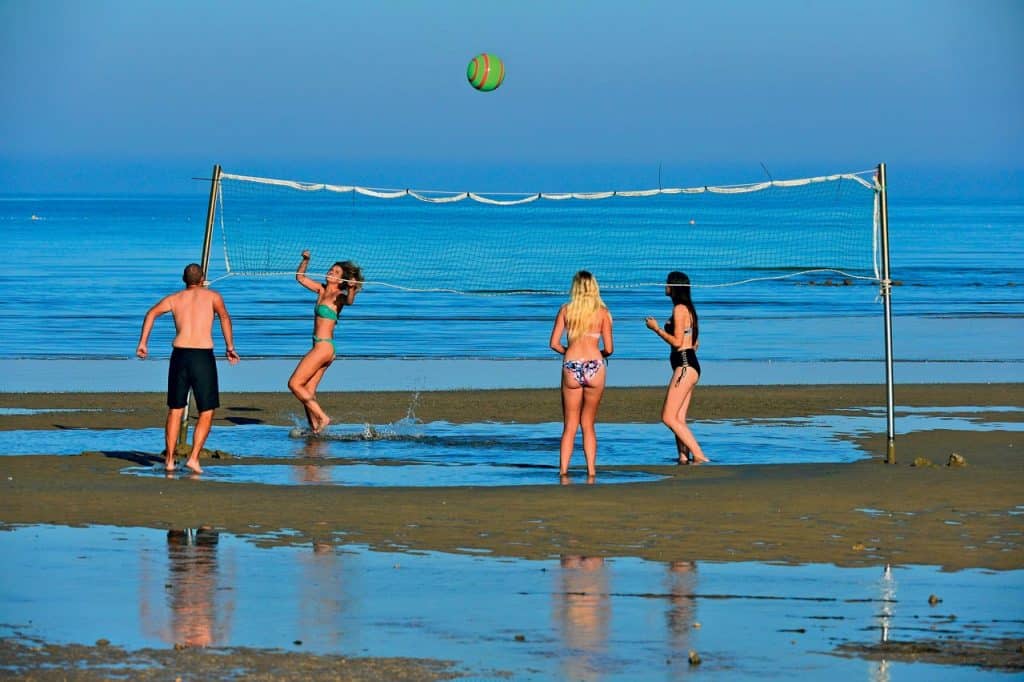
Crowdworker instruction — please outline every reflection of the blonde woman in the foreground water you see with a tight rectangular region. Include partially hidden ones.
[553,554,611,680]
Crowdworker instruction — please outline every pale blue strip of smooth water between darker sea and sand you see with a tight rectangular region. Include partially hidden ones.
[0,355,1024,394]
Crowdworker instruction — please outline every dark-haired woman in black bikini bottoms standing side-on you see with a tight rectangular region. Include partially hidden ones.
[647,270,709,464]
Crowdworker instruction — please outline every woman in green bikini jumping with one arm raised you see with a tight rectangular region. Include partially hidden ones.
[288,250,362,433]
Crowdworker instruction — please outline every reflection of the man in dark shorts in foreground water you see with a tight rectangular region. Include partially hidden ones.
[167,527,227,646]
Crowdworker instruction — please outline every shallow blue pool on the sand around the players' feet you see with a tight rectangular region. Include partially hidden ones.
[0,406,1024,486]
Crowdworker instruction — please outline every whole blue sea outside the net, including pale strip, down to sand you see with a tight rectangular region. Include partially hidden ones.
[0,189,1024,391]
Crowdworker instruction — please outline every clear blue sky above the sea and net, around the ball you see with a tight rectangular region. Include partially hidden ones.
[0,0,1024,193]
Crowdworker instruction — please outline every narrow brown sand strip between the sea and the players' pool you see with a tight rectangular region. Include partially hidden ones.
[0,383,1024,428]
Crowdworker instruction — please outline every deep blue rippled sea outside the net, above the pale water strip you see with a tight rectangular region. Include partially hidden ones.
[0,197,1024,363]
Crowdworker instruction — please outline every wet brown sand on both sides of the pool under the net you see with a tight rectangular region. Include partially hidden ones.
[0,384,1024,570]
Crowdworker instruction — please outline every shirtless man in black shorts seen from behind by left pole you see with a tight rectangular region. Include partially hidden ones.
[135,263,239,474]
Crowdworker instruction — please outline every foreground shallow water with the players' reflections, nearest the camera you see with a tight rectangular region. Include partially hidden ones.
[0,526,1024,681]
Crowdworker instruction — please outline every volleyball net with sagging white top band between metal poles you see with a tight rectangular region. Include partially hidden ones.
[214,169,880,294]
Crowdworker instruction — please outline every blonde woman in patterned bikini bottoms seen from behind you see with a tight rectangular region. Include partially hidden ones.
[550,270,614,481]
